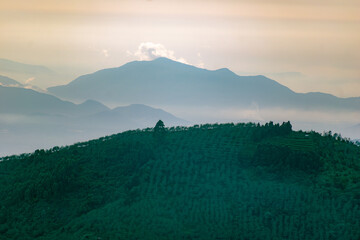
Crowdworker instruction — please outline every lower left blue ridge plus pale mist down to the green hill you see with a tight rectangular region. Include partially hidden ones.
[0,83,188,156]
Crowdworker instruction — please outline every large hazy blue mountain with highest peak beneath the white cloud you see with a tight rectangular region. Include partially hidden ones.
[48,58,360,110]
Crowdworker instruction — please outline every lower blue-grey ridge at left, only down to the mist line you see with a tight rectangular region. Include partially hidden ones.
[0,85,186,122]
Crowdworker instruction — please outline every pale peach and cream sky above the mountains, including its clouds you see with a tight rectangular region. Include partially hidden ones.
[0,0,360,97]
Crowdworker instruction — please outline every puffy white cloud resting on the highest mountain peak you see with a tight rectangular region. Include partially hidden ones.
[133,42,187,63]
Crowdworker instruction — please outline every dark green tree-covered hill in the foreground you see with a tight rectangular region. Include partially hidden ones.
[0,122,360,240]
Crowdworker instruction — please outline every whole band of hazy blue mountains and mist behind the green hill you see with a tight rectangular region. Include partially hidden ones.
[0,58,360,155]
